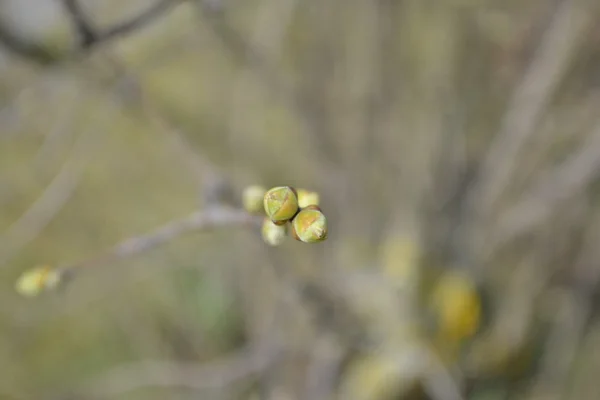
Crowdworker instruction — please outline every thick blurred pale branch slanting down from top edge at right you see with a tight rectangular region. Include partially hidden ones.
[469,0,588,238]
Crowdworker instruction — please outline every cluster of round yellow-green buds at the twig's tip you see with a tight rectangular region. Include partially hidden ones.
[243,186,327,246]
